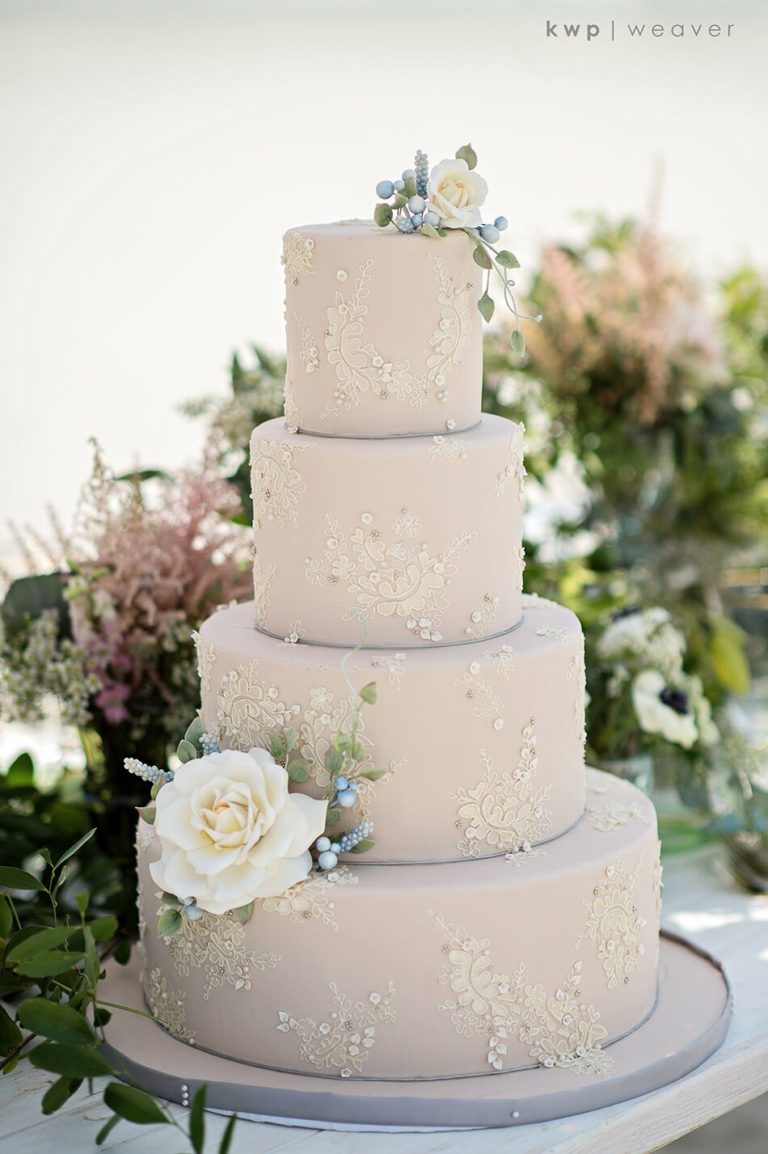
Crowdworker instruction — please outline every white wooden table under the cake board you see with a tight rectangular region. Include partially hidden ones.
[0,849,768,1154]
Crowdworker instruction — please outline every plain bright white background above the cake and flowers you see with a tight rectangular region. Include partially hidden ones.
[0,0,768,539]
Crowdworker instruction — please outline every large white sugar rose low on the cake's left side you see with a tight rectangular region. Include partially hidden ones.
[150,749,327,914]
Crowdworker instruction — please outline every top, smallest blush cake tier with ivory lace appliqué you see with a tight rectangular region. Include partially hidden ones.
[283,220,482,437]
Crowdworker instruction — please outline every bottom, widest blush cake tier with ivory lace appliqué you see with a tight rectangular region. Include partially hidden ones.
[138,771,661,1080]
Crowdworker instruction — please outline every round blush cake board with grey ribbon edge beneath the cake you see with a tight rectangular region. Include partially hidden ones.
[103,932,731,1131]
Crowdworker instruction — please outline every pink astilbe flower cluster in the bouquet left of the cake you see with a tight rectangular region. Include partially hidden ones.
[67,448,250,734]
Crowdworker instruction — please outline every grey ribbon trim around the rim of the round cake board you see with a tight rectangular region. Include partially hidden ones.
[104,930,732,1130]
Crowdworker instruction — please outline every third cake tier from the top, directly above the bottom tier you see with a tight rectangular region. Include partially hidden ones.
[197,597,585,862]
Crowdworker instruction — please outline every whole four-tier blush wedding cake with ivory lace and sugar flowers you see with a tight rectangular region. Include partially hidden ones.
[123,151,724,1117]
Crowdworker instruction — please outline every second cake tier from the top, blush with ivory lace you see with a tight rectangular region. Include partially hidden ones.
[251,415,525,649]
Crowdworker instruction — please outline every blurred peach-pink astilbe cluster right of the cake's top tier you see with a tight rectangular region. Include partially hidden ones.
[528,223,724,426]
